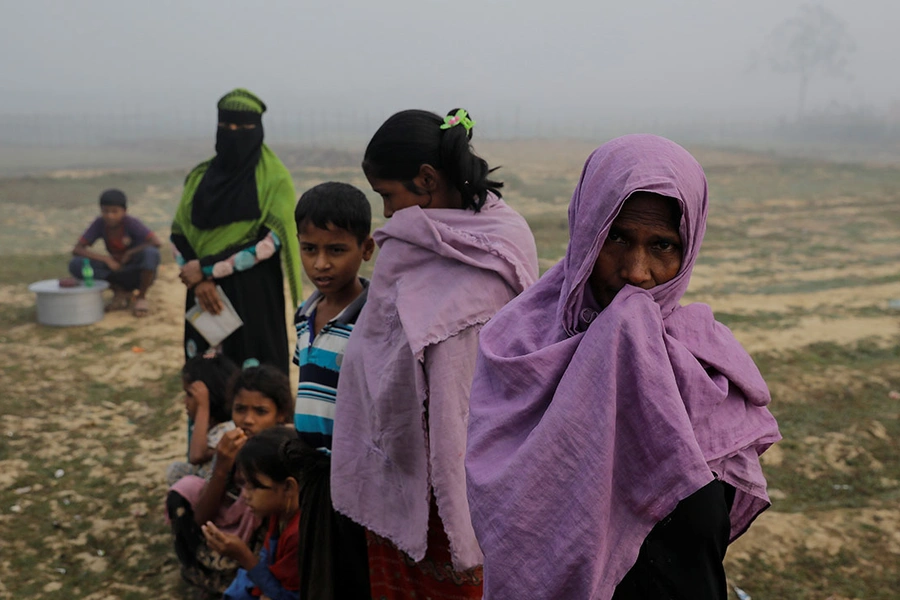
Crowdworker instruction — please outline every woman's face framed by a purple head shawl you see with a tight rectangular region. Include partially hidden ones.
[588,192,682,308]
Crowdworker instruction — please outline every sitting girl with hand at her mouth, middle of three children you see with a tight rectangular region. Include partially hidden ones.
[166,365,294,594]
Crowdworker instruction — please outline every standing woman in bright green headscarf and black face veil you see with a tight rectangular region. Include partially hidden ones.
[171,88,300,373]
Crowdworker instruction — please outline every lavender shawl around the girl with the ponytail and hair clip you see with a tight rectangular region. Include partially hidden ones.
[331,196,537,569]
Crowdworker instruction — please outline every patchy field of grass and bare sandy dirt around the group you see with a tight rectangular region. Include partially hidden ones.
[0,142,900,600]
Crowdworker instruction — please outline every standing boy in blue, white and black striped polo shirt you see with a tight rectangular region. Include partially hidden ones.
[294,182,375,598]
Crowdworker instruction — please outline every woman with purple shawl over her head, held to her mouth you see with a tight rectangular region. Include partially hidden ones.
[466,135,780,600]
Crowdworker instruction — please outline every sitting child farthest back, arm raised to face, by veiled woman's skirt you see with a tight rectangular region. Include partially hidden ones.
[166,354,237,486]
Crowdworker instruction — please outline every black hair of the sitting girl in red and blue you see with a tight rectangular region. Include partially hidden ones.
[235,427,327,488]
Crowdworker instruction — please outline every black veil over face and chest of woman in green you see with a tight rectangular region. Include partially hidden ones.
[191,117,263,229]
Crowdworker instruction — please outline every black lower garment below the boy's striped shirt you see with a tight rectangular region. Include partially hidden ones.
[299,453,371,600]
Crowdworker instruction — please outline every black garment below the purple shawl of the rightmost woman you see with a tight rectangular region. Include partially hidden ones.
[612,480,735,600]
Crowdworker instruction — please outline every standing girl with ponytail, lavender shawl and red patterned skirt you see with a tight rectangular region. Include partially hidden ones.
[331,110,537,600]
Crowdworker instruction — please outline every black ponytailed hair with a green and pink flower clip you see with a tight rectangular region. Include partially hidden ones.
[362,108,503,212]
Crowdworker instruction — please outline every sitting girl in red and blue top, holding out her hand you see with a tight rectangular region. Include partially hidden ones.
[203,427,318,600]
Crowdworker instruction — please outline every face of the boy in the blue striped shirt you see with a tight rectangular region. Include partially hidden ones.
[297,223,375,300]
